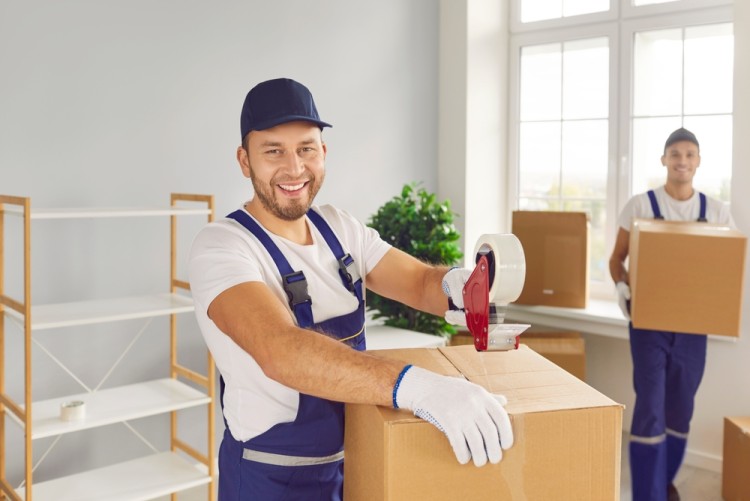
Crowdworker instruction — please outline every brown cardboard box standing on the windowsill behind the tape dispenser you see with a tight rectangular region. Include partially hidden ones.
[512,211,589,308]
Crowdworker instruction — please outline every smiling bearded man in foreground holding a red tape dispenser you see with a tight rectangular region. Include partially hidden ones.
[189,78,513,501]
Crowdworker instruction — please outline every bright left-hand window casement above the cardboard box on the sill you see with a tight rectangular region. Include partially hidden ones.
[518,37,609,280]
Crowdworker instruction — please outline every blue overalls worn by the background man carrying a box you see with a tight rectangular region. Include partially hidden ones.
[629,191,707,501]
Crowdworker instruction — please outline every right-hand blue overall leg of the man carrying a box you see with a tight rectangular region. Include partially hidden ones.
[665,334,707,483]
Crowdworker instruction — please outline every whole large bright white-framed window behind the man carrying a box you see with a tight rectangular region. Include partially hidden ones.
[509,0,734,297]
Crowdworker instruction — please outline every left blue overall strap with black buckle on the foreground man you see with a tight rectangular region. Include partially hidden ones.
[227,209,314,328]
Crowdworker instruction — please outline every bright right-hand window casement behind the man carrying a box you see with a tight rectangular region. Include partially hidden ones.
[632,23,734,202]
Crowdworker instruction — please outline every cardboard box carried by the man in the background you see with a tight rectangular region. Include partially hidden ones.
[628,219,747,337]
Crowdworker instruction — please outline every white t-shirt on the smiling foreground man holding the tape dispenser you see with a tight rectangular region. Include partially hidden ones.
[188,201,391,442]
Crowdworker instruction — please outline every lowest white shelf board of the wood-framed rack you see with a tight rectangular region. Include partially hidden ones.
[19,452,211,501]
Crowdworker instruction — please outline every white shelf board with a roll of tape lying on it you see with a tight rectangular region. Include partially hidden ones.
[8,378,211,440]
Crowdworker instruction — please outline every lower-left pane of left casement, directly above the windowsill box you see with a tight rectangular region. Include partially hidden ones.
[519,122,560,197]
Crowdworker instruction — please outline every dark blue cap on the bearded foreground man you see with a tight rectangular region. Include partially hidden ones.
[240,78,331,139]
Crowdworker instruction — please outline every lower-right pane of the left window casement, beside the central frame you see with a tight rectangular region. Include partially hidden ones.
[561,120,609,195]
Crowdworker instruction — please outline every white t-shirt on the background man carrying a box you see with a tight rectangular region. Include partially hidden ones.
[617,186,735,231]
